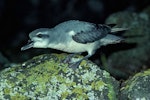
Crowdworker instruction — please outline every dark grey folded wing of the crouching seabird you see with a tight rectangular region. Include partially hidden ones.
[72,25,111,44]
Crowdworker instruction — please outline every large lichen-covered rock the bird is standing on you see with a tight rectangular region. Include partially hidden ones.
[0,54,119,100]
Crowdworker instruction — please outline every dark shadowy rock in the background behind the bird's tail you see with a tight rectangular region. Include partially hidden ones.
[106,12,150,78]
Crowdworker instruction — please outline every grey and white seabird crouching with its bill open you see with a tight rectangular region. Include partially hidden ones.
[21,20,127,68]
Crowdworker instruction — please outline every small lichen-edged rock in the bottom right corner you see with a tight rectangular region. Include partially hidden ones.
[120,69,150,100]
